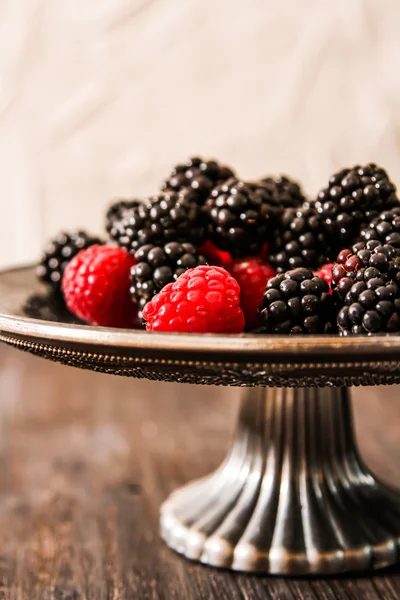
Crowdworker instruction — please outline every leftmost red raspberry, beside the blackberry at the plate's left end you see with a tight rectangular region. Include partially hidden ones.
[62,245,138,327]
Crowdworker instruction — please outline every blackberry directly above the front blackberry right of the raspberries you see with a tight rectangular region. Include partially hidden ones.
[269,203,335,273]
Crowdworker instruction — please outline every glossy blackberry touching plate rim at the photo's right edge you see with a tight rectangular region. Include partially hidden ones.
[337,278,400,335]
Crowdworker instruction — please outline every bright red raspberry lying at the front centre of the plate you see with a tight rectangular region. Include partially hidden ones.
[143,265,244,333]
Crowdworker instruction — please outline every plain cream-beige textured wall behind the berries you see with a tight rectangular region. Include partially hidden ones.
[0,0,400,265]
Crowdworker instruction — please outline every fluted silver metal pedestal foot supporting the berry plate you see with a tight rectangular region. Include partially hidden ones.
[161,387,400,575]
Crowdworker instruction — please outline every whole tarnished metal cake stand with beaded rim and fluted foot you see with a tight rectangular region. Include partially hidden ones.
[0,267,400,575]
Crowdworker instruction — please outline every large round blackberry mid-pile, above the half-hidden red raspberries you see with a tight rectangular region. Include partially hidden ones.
[204,179,281,257]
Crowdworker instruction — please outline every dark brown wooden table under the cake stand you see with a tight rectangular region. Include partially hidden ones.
[0,346,400,600]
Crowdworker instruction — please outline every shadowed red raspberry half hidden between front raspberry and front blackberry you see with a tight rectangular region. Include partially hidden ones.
[229,257,276,329]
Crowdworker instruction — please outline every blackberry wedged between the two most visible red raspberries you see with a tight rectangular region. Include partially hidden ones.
[131,242,206,309]
